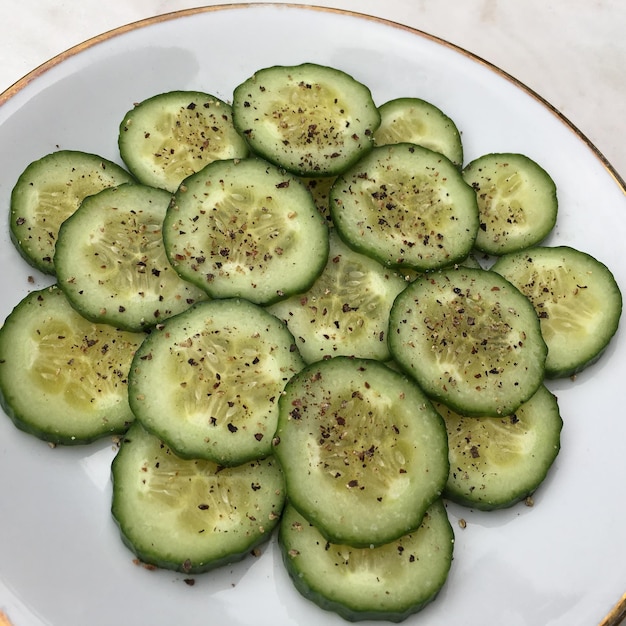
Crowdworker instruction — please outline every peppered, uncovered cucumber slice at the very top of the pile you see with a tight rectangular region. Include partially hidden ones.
[232,63,380,176]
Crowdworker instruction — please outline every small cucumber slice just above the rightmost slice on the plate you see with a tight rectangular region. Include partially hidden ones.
[463,153,558,255]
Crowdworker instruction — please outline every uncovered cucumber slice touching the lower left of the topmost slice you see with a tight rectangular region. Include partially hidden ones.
[163,159,328,304]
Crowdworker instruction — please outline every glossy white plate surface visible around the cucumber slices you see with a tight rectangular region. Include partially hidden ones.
[0,5,626,626]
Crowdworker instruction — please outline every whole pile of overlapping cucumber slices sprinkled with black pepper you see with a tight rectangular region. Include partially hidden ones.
[0,63,622,622]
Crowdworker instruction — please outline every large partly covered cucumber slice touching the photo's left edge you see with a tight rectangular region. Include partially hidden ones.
[0,286,145,445]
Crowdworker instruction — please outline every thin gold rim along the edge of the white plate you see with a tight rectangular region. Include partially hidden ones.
[0,2,626,626]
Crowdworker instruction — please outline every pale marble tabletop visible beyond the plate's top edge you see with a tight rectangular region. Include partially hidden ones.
[0,0,626,183]
